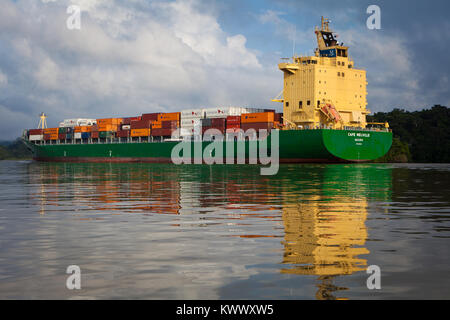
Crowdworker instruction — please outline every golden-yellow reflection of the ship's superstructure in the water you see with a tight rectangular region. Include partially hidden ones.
[282,196,369,276]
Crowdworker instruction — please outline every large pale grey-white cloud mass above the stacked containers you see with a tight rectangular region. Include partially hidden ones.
[0,0,280,138]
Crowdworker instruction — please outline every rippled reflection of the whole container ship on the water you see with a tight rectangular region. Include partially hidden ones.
[23,163,392,299]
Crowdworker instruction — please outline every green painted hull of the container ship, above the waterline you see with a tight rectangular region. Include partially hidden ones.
[29,129,392,162]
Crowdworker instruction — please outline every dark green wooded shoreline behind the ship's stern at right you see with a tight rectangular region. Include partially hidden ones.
[367,105,450,162]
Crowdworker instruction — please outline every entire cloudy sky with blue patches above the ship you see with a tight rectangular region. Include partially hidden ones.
[0,0,450,140]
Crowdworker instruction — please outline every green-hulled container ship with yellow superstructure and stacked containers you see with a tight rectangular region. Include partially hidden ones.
[22,17,392,163]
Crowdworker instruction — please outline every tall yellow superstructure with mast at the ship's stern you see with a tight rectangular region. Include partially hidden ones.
[273,18,370,129]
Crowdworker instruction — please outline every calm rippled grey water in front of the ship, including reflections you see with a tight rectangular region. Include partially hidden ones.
[0,161,450,299]
